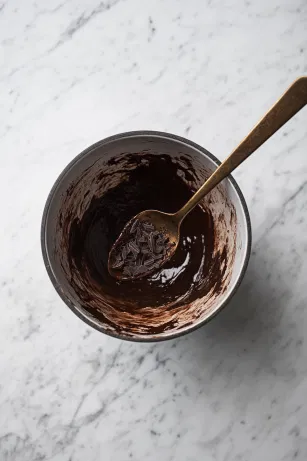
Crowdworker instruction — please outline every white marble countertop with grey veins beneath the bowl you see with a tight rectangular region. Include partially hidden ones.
[0,0,307,461]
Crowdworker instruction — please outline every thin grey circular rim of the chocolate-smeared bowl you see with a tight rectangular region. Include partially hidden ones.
[40,130,252,343]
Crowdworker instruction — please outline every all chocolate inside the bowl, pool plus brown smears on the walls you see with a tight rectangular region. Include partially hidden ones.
[60,153,234,334]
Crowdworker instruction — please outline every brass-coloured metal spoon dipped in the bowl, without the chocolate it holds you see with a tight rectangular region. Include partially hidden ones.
[108,77,307,279]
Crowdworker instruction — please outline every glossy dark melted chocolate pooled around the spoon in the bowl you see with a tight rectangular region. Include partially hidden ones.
[68,154,227,316]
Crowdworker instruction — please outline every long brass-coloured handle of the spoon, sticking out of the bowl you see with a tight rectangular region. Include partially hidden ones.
[175,77,307,222]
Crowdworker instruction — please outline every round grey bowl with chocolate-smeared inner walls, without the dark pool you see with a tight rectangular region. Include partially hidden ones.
[41,131,251,341]
